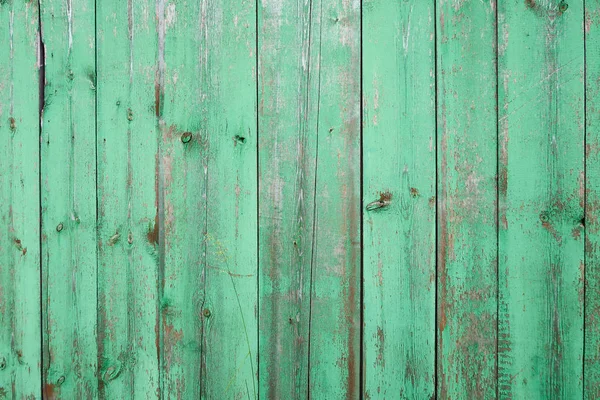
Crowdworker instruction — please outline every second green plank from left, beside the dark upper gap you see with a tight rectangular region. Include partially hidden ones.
[40,0,98,399]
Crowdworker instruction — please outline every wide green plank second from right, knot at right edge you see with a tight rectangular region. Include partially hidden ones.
[498,0,584,399]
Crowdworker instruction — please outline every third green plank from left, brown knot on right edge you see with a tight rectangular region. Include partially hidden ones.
[96,0,160,399]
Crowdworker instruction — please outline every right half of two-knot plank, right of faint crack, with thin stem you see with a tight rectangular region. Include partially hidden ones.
[202,0,258,399]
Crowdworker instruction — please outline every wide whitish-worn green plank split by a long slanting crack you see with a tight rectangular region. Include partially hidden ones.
[258,0,360,398]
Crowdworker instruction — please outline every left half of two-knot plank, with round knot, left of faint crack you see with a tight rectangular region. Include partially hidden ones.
[157,0,205,399]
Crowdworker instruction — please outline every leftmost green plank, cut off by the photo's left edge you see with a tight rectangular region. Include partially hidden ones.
[0,1,42,399]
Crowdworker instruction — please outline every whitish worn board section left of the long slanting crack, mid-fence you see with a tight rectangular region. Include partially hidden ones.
[258,0,322,399]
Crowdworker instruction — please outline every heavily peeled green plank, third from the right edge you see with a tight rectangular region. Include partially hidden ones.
[436,0,497,399]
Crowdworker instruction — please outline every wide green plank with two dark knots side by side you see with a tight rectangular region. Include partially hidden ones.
[159,1,258,398]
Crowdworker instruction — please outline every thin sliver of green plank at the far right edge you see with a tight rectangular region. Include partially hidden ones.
[583,0,600,400]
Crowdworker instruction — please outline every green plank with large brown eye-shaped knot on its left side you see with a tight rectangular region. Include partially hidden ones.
[362,0,436,399]
